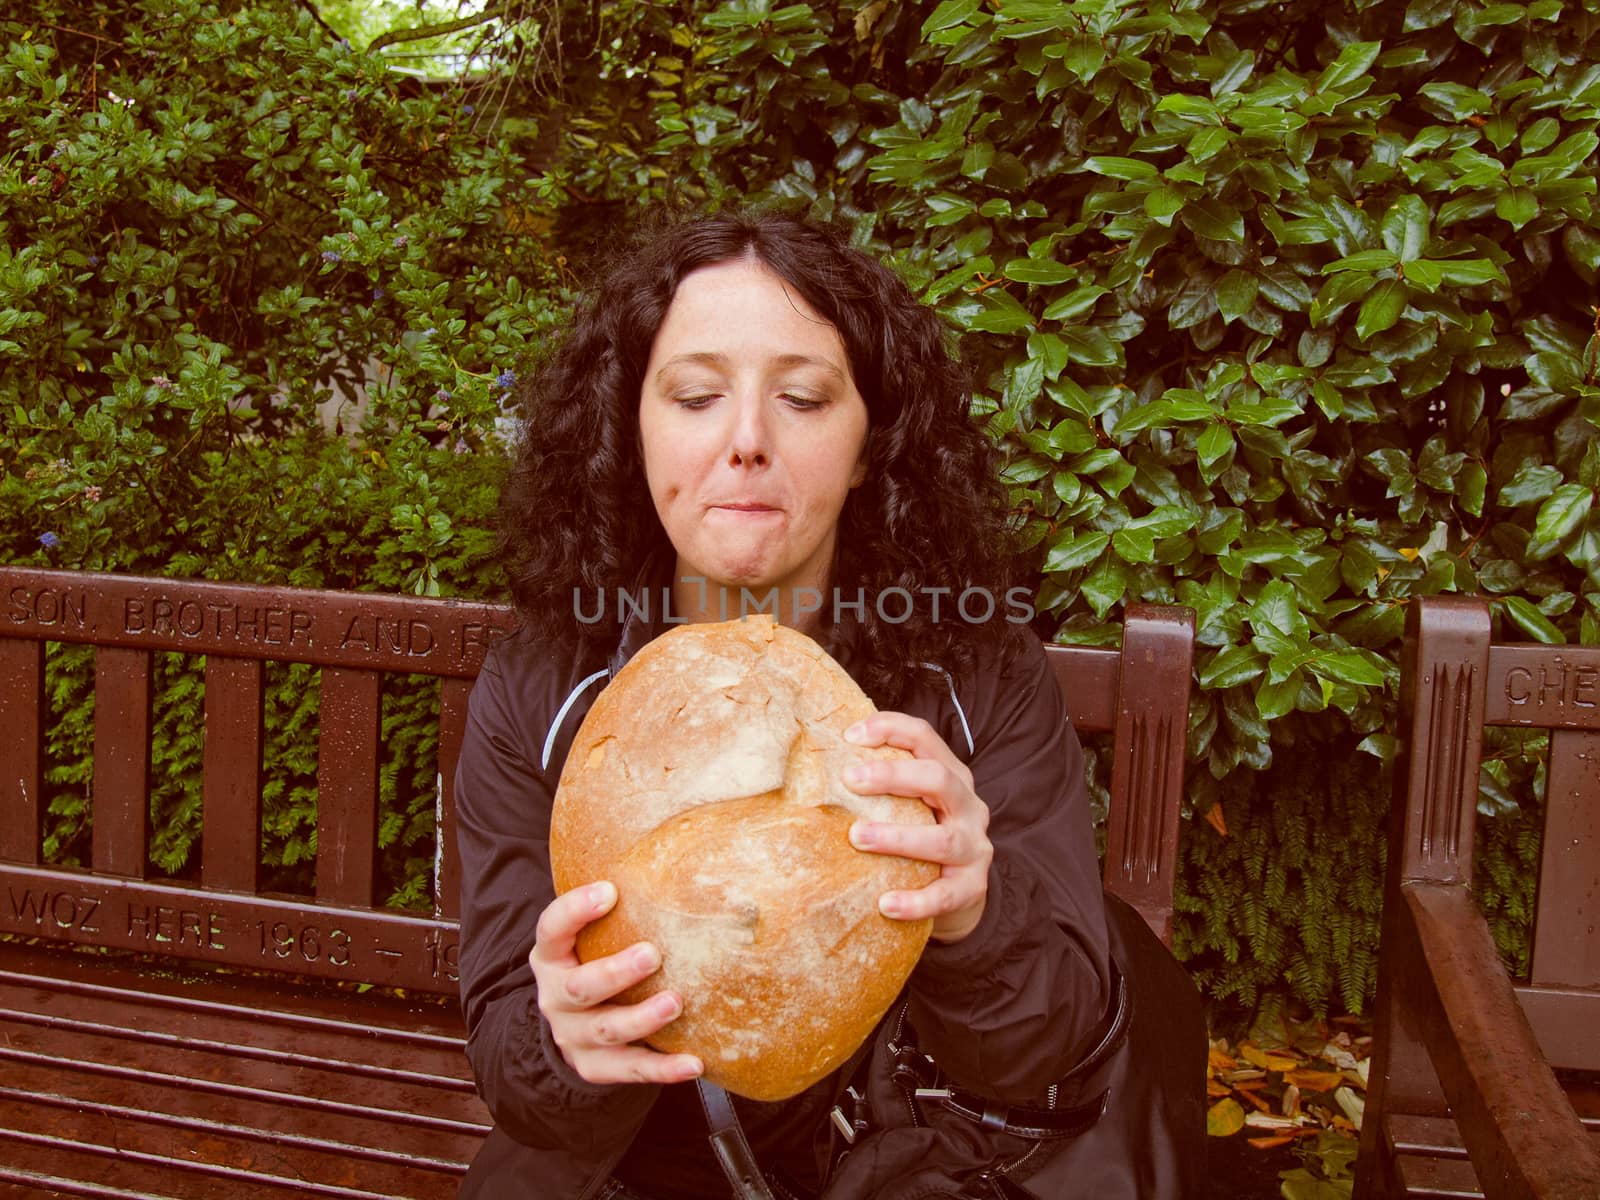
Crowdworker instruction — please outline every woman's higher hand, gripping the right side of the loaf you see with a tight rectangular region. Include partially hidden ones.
[845,712,995,942]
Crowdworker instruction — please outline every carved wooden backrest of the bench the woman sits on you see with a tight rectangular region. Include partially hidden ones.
[0,568,1192,995]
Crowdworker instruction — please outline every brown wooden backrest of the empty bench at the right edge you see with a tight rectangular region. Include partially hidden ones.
[1400,597,1600,1070]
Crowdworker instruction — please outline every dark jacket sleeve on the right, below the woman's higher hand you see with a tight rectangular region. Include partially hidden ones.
[909,634,1110,1104]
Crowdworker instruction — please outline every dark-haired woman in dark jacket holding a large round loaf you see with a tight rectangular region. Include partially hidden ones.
[458,216,1177,1200]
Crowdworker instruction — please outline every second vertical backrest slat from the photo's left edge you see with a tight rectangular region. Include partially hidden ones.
[93,646,150,878]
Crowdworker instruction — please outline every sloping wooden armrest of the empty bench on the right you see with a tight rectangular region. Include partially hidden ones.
[1395,882,1600,1200]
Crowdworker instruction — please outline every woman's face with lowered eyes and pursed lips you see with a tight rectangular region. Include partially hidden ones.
[638,259,867,594]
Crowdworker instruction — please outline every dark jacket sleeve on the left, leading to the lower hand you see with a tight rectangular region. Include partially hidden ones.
[456,651,658,1157]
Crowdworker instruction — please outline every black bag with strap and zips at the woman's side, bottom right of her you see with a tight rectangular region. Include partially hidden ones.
[821,894,1206,1200]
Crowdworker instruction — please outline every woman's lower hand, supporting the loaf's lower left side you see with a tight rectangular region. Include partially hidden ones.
[528,882,702,1083]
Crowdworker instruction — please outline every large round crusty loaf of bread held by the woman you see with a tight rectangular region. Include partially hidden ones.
[550,616,938,1101]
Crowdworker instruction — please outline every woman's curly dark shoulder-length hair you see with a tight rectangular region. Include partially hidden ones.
[501,213,1016,707]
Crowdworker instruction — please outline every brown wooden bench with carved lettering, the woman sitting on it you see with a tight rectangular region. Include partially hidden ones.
[0,568,1198,1200]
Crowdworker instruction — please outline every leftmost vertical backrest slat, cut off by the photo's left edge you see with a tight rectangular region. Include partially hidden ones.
[0,637,45,866]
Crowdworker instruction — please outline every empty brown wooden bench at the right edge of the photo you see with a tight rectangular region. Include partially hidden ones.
[1355,597,1600,1200]
